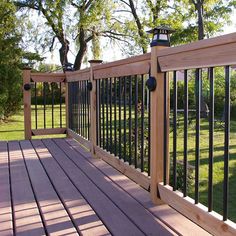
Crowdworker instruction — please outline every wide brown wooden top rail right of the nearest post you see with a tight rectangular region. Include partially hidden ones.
[158,33,236,72]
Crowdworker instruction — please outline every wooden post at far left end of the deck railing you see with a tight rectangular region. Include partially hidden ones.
[23,68,32,139]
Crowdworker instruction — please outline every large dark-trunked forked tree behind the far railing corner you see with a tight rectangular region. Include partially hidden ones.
[15,0,119,70]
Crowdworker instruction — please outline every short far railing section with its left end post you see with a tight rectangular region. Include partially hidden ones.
[23,69,66,139]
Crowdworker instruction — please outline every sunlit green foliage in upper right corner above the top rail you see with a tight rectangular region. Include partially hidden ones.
[178,0,236,41]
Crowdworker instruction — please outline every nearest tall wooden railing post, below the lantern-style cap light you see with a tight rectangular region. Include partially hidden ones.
[150,38,169,204]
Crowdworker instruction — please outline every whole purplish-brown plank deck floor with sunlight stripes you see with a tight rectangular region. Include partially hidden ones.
[0,139,208,236]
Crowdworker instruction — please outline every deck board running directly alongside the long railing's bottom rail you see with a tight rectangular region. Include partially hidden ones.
[66,139,210,235]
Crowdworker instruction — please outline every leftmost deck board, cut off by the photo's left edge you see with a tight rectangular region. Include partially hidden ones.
[0,142,13,236]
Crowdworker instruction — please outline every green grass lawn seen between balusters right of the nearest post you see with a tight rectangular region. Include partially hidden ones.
[170,119,236,222]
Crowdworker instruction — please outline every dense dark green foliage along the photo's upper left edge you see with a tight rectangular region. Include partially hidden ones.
[0,0,22,120]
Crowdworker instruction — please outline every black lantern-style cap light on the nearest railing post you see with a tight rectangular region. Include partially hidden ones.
[147,26,174,47]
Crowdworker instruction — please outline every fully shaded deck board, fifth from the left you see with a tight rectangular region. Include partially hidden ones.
[43,140,144,235]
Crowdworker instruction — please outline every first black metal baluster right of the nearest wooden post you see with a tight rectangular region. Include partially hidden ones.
[173,71,178,191]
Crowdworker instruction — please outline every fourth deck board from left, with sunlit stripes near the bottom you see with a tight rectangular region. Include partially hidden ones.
[32,140,110,235]
